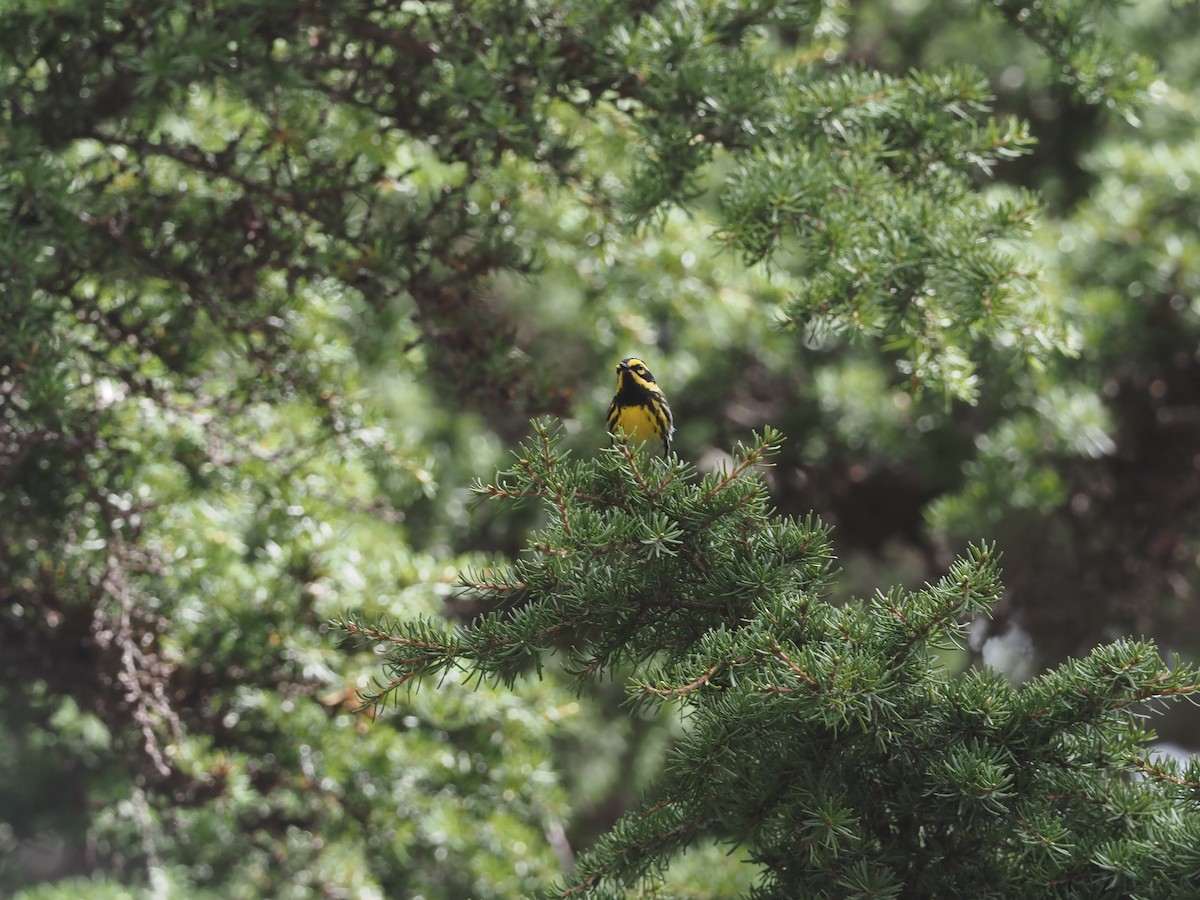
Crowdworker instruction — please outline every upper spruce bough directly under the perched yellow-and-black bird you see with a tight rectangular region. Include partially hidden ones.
[337,420,830,703]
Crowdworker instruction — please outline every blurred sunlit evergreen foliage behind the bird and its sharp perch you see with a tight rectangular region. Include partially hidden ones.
[0,0,1196,896]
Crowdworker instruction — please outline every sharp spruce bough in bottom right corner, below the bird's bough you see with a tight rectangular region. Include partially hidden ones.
[549,545,1200,898]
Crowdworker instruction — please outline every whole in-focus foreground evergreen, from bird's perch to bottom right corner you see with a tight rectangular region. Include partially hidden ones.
[342,424,1200,898]
